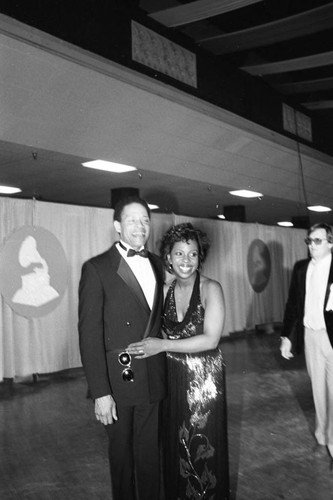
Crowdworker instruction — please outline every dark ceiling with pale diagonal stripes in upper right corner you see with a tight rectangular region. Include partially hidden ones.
[139,0,333,117]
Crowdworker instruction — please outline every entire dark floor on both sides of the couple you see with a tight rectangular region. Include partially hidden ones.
[0,332,333,500]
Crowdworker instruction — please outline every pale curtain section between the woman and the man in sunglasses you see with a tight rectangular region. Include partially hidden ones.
[175,216,307,335]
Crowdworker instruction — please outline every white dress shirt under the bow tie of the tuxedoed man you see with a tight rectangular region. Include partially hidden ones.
[117,241,156,309]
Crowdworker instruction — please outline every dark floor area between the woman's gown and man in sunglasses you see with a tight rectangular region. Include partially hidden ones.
[224,332,333,500]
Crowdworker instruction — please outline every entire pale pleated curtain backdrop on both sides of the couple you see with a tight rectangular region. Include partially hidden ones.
[0,198,307,381]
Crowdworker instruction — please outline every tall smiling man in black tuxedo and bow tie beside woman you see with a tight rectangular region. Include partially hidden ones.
[79,197,165,500]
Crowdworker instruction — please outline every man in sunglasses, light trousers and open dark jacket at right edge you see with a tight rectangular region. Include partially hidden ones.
[280,223,333,464]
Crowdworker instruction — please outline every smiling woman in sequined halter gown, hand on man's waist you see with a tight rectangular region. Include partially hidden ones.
[128,223,229,500]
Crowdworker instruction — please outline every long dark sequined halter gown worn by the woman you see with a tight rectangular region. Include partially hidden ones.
[162,273,229,500]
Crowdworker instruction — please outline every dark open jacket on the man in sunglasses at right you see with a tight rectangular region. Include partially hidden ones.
[281,259,333,353]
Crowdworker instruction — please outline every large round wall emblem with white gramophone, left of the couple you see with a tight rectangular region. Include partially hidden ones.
[0,226,68,318]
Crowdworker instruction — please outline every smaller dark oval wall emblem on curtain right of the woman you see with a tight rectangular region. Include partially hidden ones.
[247,239,271,293]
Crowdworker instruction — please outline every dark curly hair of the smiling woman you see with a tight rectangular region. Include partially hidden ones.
[160,222,210,272]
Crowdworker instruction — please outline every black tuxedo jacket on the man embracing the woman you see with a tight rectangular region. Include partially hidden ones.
[79,245,166,405]
